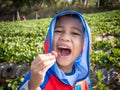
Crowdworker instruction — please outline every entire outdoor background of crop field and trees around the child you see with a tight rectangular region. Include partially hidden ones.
[0,0,120,90]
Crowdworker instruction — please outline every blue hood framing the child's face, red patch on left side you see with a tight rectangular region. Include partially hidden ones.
[44,10,91,84]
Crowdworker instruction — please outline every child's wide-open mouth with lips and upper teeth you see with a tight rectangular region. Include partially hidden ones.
[58,46,71,56]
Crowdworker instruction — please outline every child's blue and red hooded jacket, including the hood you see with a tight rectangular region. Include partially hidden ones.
[19,10,91,90]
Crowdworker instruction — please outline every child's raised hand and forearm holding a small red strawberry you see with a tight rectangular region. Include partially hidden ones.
[29,51,57,90]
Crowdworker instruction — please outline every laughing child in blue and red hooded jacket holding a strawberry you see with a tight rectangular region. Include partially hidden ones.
[18,10,92,90]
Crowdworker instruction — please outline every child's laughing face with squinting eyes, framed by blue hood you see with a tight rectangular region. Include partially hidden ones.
[53,16,83,71]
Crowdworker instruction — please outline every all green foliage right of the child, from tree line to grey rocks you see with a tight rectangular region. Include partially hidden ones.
[85,10,120,68]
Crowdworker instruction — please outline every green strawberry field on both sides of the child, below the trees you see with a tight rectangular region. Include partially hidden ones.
[0,10,120,90]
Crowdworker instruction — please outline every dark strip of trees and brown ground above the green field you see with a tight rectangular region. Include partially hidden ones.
[0,0,120,21]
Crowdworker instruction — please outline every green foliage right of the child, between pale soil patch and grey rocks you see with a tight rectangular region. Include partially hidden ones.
[90,38,120,68]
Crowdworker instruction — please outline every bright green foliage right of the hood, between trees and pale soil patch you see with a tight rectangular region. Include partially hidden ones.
[85,10,120,35]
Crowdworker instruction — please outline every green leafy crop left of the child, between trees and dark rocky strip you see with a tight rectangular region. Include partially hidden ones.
[0,19,50,64]
